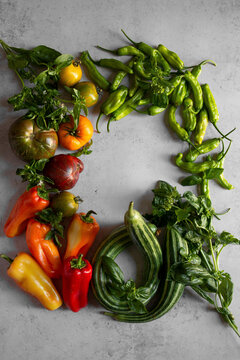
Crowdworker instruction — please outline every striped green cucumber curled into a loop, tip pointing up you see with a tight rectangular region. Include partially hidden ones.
[92,204,162,314]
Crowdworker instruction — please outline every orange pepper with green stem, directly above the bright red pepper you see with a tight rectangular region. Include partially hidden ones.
[64,210,99,259]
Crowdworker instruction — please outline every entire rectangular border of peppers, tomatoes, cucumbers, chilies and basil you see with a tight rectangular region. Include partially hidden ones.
[0,30,240,336]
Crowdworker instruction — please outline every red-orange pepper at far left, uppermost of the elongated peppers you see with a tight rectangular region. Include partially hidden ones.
[4,186,49,237]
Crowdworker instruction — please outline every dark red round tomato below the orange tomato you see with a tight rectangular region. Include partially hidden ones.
[43,154,84,190]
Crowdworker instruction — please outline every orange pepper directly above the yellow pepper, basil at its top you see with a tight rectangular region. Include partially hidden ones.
[26,218,62,278]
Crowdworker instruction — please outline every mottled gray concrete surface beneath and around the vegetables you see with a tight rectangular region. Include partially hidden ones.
[0,0,240,360]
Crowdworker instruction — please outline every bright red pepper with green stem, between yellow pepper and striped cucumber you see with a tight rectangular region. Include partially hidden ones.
[62,254,92,312]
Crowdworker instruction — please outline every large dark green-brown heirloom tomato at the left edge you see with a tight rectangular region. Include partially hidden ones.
[8,116,58,162]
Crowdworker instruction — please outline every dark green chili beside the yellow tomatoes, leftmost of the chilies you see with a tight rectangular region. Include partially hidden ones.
[80,51,110,90]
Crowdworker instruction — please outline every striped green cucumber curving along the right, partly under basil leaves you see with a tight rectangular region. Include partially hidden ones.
[105,228,187,323]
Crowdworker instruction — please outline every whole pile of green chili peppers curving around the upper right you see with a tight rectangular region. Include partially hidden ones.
[80,30,234,198]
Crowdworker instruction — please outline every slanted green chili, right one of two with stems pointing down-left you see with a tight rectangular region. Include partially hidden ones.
[107,89,144,131]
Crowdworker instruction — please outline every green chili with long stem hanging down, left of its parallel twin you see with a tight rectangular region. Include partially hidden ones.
[96,85,128,132]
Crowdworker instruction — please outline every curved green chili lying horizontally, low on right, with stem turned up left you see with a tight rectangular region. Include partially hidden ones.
[175,153,218,174]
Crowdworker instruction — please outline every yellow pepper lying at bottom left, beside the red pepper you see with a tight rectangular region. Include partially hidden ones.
[0,252,62,310]
